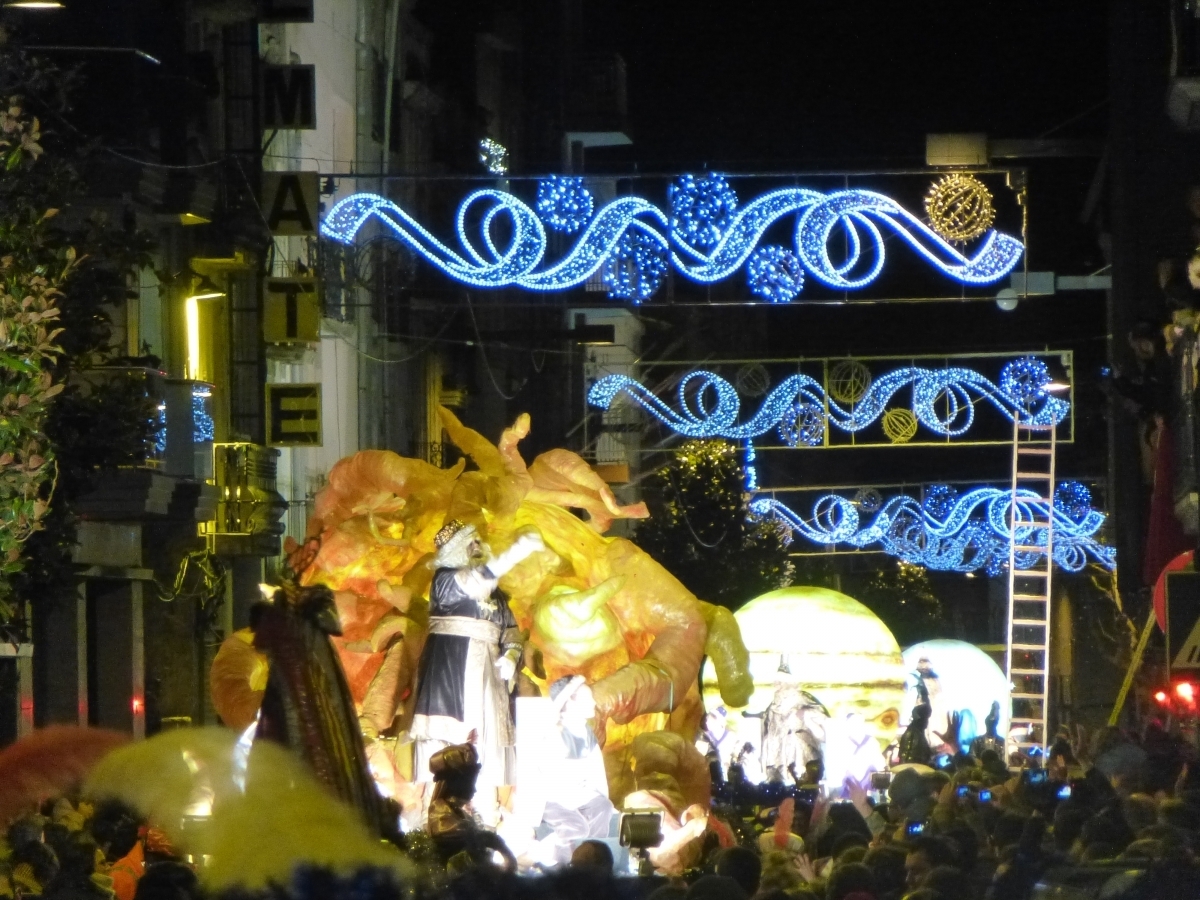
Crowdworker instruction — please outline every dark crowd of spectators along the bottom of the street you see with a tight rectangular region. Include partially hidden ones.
[7,724,1200,900]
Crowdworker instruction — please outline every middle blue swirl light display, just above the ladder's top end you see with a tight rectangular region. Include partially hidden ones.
[588,356,1070,446]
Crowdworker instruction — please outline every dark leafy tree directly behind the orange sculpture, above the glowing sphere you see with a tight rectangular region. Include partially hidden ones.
[635,440,793,608]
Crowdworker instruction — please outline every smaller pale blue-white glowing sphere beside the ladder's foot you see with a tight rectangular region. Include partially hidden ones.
[902,641,1009,744]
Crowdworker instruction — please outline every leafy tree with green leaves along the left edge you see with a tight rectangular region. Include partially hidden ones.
[0,54,155,640]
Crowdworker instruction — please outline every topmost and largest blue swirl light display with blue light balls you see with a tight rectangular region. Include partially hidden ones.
[320,175,1025,302]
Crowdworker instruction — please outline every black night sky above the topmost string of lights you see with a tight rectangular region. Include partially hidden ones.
[586,0,1108,170]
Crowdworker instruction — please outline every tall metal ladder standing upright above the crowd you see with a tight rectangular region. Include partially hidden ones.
[1006,418,1057,764]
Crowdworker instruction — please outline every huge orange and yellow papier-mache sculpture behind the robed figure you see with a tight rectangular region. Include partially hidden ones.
[214,409,752,815]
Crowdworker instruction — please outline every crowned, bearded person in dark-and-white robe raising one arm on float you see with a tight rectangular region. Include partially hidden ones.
[410,520,545,817]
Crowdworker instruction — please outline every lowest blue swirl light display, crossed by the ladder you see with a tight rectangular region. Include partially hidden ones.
[750,481,1116,575]
